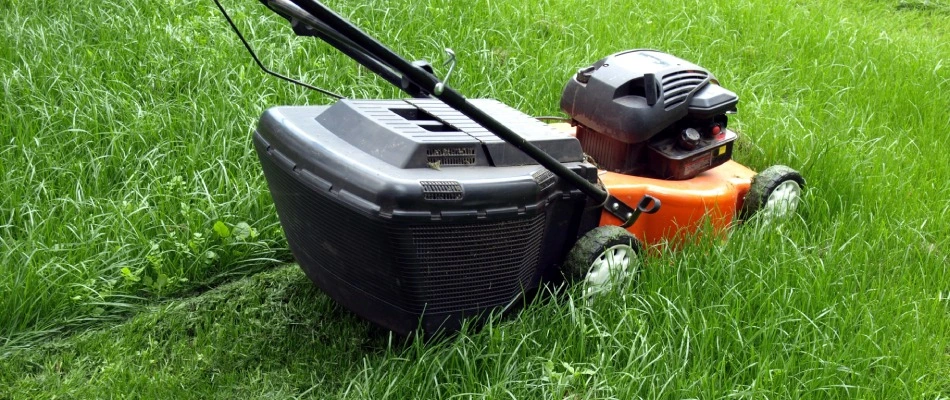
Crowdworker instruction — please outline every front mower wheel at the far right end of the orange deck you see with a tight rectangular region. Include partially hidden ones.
[742,165,805,220]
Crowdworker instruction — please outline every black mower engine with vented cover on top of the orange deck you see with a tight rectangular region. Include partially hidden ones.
[561,50,739,180]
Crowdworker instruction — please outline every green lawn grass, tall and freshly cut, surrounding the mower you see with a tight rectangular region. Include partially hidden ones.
[0,0,950,399]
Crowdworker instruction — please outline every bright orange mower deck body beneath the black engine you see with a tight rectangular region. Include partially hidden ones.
[552,124,755,245]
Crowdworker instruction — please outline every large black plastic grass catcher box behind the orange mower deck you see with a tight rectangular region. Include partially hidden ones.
[254,100,599,334]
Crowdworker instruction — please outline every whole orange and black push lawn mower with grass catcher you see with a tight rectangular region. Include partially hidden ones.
[215,0,804,335]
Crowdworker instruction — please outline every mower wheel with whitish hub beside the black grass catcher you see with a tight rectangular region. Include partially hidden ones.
[561,225,640,295]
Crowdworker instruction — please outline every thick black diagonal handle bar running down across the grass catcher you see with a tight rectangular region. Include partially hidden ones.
[260,0,660,225]
